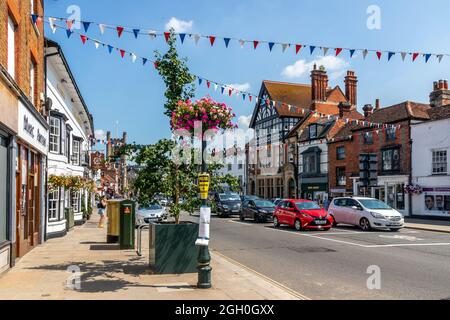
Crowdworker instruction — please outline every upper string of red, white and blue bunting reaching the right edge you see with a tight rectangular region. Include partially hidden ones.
[31,14,450,63]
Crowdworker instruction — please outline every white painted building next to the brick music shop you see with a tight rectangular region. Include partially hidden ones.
[45,40,94,238]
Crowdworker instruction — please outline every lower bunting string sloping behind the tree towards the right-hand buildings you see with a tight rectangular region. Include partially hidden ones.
[44,20,399,129]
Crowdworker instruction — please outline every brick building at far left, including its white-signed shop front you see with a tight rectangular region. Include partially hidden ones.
[0,0,48,272]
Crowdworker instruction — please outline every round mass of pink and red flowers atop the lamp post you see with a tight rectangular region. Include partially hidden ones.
[171,97,237,132]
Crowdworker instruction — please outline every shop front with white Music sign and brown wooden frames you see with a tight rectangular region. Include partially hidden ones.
[15,101,48,257]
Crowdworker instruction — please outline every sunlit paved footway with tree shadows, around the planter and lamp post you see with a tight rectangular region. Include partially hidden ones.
[0,213,306,300]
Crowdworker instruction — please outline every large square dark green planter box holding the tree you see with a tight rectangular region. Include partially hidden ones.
[149,222,199,274]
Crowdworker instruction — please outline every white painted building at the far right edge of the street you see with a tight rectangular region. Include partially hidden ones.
[411,105,450,218]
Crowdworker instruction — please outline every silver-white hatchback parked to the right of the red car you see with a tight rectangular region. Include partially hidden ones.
[328,197,405,231]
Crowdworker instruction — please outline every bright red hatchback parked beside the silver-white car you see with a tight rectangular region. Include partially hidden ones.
[273,199,333,231]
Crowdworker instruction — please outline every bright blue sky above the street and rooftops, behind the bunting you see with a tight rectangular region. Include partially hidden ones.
[45,0,450,143]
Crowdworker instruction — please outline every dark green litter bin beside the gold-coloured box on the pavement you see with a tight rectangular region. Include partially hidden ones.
[119,200,136,249]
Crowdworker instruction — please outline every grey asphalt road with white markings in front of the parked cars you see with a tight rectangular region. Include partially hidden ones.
[191,212,450,300]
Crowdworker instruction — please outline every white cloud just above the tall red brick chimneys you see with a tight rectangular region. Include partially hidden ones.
[281,56,348,79]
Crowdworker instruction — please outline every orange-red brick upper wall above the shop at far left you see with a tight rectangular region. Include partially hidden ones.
[0,0,45,110]
